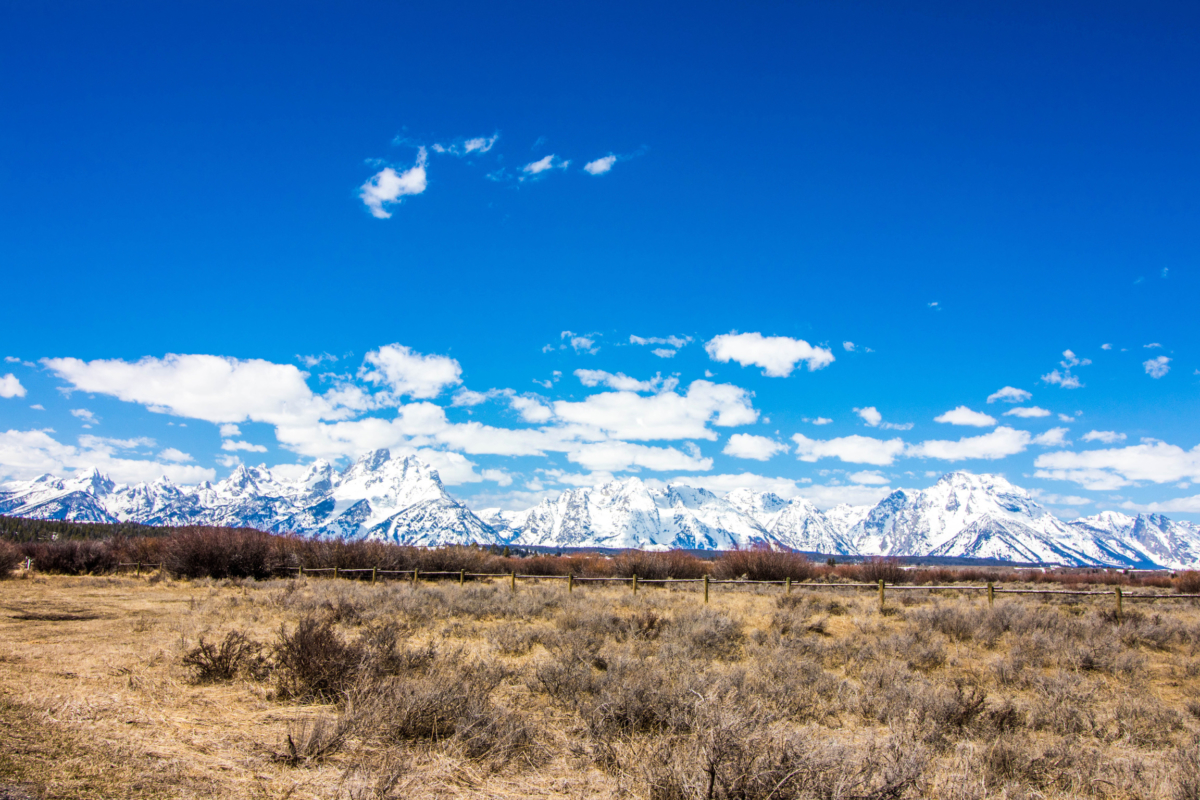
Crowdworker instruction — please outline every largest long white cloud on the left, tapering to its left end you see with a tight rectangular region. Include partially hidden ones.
[42,354,350,425]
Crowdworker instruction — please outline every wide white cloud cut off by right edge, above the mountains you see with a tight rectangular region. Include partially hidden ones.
[1033,439,1200,489]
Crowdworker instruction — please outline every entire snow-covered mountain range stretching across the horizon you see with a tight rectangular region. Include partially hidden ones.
[0,450,1200,569]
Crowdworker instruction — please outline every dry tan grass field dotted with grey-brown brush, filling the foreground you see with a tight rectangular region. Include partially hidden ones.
[0,573,1200,800]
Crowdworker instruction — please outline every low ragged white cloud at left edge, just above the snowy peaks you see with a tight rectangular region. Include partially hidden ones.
[0,431,216,483]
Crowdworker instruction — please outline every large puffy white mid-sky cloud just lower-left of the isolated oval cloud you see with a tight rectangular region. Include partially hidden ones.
[553,380,758,440]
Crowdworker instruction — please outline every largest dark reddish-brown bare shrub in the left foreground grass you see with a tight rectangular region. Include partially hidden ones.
[275,616,367,702]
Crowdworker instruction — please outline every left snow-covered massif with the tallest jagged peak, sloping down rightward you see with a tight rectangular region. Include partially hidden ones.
[0,450,496,545]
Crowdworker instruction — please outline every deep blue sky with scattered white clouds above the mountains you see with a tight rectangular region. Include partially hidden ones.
[0,2,1200,519]
